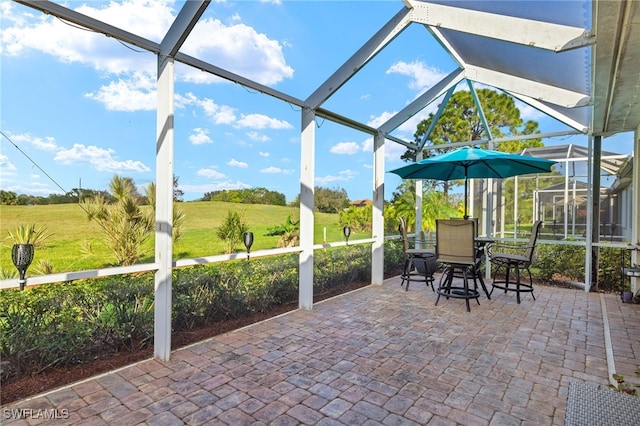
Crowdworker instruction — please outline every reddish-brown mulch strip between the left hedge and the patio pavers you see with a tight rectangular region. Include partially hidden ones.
[0,283,368,405]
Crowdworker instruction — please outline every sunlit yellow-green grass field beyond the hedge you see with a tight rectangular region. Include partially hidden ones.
[0,201,352,272]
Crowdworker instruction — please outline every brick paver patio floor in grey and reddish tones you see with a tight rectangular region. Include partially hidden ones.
[1,278,640,426]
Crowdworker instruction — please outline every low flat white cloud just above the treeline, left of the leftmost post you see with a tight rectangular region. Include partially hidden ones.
[53,144,151,173]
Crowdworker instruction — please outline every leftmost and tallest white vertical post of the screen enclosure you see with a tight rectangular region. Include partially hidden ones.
[153,55,174,361]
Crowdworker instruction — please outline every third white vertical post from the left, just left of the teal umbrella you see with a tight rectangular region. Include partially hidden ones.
[371,132,384,285]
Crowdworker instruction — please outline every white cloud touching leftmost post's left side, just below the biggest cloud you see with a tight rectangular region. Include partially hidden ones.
[84,72,158,111]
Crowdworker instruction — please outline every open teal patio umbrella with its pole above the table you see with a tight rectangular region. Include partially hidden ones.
[389,147,555,217]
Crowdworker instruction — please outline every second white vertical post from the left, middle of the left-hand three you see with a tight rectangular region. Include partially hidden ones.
[298,108,316,310]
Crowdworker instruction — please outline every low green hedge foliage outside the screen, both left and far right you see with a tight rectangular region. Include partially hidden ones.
[0,240,621,380]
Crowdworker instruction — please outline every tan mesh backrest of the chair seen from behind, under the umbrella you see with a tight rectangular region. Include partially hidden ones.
[436,219,476,265]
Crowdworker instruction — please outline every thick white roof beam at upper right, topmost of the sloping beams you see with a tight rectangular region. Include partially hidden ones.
[404,0,595,52]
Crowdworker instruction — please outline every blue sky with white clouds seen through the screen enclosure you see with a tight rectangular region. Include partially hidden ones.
[0,0,633,201]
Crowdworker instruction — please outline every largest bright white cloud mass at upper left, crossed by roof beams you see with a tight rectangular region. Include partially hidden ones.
[0,0,294,111]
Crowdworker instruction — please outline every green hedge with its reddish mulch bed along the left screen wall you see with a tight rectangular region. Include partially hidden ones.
[0,241,403,404]
